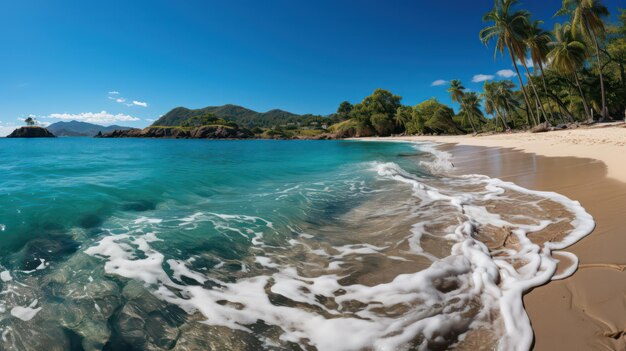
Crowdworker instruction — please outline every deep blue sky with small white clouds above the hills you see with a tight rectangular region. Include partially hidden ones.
[0,0,624,134]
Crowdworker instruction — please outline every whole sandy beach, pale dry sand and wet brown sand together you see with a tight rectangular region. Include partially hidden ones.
[356,123,626,350]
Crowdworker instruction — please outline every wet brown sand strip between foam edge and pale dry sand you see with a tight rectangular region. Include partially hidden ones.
[436,144,626,350]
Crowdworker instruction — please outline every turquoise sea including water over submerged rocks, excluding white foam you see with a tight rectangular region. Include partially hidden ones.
[0,138,417,350]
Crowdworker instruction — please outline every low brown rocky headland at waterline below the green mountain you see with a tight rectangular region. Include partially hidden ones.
[97,126,254,139]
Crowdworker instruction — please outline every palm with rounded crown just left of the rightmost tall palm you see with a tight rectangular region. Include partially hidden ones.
[548,22,591,120]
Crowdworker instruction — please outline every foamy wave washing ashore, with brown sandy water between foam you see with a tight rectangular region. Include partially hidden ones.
[75,145,594,350]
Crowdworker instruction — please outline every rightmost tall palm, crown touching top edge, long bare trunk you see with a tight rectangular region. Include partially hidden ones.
[556,0,609,119]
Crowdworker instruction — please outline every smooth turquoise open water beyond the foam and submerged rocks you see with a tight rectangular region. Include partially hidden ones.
[0,138,416,258]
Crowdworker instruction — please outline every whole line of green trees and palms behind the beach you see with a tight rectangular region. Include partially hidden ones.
[332,0,626,136]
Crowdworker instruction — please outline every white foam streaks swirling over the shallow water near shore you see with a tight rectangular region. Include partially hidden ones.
[81,145,594,351]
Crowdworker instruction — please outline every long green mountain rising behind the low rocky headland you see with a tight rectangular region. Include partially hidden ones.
[152,105,324,128]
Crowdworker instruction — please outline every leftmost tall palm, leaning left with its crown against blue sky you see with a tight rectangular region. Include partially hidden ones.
[480,0,535,123]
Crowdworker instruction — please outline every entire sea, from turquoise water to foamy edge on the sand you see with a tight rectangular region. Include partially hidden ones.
[0,138,593,350]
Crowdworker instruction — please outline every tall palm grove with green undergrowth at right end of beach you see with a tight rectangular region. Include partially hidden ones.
[479,0,626,128]
